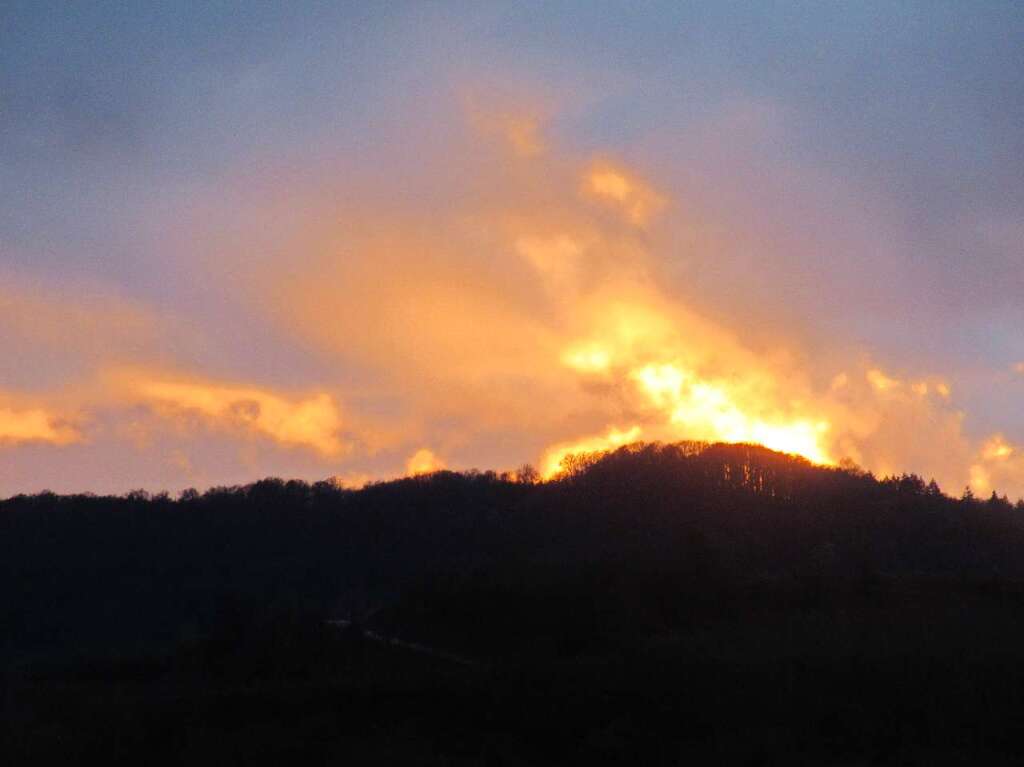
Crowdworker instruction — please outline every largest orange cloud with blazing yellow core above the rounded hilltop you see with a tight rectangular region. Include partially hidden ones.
[207,103,1024,497]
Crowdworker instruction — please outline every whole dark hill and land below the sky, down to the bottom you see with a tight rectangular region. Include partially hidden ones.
[0,442,1024,764]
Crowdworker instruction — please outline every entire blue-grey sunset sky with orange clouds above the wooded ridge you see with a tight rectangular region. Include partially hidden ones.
[0,0,1024,498]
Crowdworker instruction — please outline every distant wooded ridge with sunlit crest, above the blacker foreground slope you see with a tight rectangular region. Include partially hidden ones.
[6,442,1024,653]
